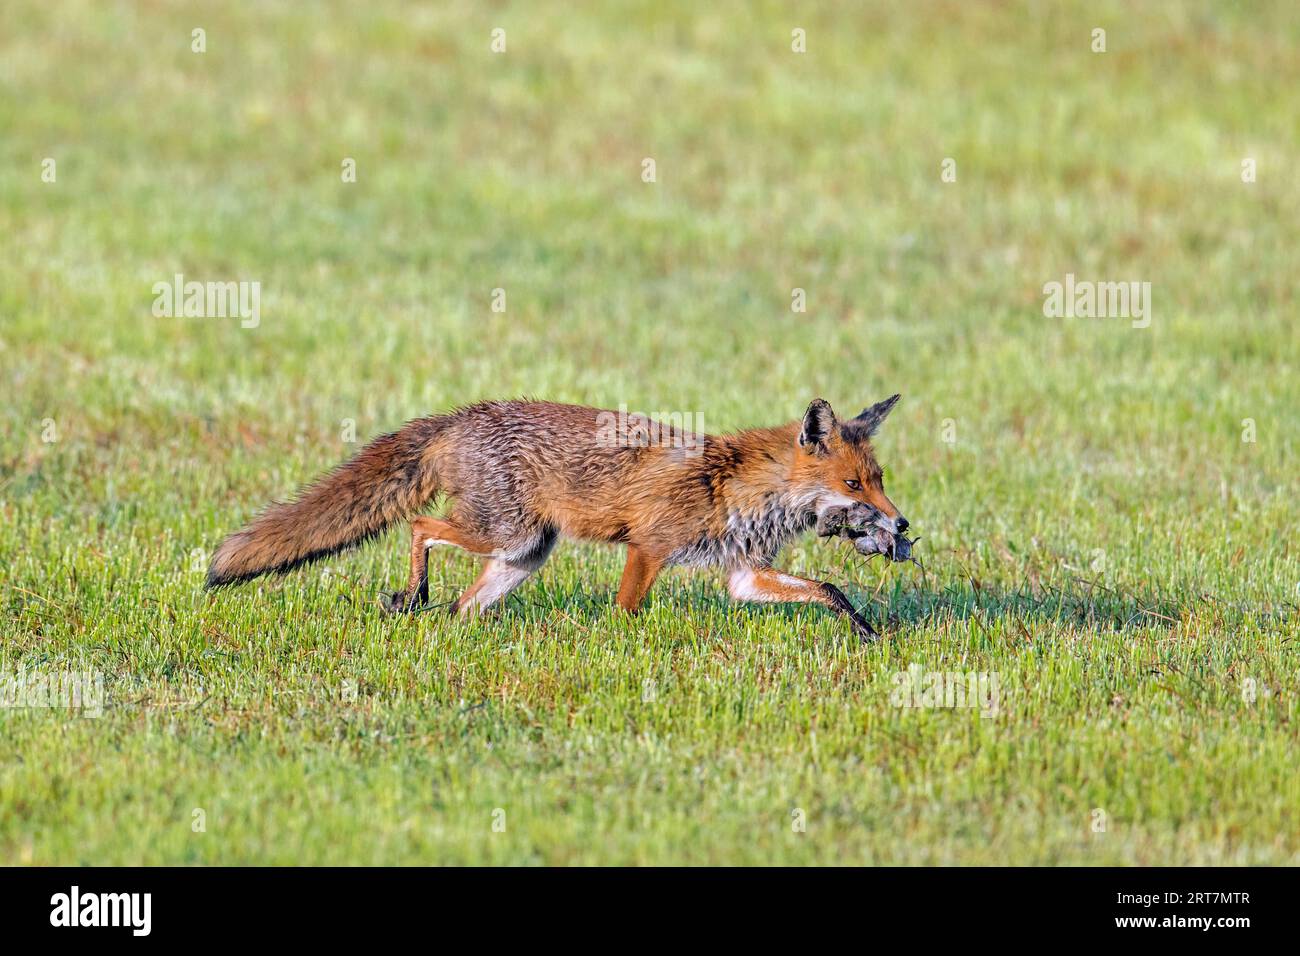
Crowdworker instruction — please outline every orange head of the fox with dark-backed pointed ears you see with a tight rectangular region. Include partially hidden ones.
[792,395,907,535]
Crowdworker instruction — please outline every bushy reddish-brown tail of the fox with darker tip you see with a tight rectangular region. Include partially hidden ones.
[207,418,446,588]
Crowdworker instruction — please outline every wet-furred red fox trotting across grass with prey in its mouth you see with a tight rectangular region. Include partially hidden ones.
[207,395,907,640]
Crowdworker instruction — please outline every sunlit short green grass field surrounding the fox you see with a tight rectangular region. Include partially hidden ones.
[0,0,1300,865]
